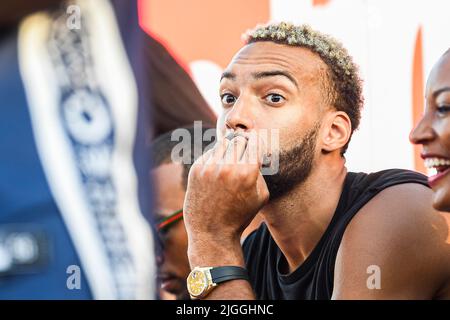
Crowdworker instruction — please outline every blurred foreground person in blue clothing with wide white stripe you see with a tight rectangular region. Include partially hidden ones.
[0,0,215,299]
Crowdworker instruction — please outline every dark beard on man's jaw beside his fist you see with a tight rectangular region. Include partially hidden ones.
[263,124,320,200]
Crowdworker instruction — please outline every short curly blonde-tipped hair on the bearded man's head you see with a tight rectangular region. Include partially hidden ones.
[243,22,364,154]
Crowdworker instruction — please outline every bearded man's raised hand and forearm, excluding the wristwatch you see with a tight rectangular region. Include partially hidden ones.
[183,133,269,299]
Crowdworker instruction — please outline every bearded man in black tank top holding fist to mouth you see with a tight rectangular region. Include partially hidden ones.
[183,23,450,300]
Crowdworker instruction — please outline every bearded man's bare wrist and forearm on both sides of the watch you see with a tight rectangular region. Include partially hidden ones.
[188,239,255,300]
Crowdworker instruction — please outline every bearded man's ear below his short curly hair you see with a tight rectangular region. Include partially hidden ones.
[322,111,352,152]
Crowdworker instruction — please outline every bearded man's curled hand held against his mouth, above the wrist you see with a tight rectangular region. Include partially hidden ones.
[184,133,269,246]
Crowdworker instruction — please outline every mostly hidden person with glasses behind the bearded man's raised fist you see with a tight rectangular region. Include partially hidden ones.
[151,126,261,300]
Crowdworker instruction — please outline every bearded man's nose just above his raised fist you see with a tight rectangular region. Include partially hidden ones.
[225,96,255,131]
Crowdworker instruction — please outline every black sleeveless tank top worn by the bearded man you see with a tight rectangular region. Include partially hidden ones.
[243,169,428,300]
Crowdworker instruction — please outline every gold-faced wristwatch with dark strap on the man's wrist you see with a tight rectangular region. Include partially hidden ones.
[187,266,250,299]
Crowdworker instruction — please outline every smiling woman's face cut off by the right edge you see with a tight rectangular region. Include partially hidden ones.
[410,50,450,211]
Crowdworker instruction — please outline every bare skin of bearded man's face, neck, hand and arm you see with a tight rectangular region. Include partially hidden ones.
[184,41,450,299]
